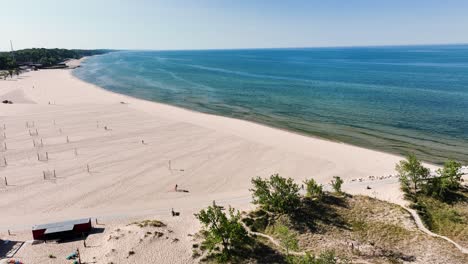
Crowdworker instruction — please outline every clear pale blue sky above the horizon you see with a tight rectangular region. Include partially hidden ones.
[0,0,468,50]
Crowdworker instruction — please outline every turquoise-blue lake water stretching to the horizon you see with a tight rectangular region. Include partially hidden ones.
[74,45,468,162]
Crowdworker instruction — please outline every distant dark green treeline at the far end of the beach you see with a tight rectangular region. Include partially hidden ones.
[0,48,110,70]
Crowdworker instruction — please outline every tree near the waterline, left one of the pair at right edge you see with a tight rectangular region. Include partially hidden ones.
[395,154,430,194]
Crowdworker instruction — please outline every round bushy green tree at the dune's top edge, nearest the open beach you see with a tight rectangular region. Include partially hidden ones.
[250,174,301,214]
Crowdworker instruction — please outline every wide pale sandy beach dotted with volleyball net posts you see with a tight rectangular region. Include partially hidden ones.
[0,59,435,263]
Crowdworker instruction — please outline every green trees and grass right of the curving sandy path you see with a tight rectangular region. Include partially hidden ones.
[396,155,468,247]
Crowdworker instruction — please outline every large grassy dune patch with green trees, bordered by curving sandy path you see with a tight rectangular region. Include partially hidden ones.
[192,174,468,264]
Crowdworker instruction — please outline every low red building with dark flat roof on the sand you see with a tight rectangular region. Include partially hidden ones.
[32,218,93,240]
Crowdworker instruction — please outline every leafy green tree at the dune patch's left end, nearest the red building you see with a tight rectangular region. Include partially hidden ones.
[195,205,250,261]
